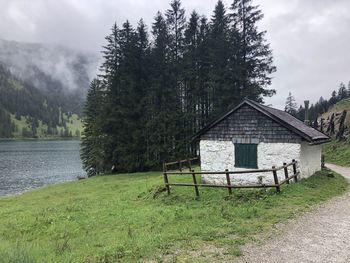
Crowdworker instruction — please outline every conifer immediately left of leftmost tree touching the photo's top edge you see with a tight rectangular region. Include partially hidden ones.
[146,12,177,167]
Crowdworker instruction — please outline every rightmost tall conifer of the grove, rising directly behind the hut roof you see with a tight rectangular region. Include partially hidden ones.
[231,0,276,102]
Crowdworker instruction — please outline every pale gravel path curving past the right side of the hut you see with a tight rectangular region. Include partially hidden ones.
[239,164,350,263]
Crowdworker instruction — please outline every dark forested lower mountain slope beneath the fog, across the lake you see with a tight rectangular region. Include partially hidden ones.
[0,63,82,138]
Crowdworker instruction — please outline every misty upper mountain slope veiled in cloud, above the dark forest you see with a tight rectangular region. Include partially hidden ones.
[0,40,98,114]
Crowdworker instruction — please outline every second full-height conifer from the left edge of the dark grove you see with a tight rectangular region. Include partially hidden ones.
[110,21,142,172]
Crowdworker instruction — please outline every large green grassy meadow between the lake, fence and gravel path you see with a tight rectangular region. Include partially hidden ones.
[0,170,347,262]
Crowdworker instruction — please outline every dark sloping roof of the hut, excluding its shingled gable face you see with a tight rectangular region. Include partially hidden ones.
[193,99,330,144]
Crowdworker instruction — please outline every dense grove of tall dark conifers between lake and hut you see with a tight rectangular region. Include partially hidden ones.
[81,0,276,173]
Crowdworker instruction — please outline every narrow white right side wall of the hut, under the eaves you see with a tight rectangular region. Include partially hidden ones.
[300,142,322,178]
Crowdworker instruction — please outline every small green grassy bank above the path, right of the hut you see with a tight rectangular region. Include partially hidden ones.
[322,139,350,166]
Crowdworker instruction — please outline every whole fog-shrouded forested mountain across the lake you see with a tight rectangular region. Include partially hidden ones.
[0,40,98,138]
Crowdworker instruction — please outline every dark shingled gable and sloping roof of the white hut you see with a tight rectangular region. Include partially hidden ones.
[194,99,329,144]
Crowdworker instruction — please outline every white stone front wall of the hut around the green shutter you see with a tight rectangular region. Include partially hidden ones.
[200,140,306,184]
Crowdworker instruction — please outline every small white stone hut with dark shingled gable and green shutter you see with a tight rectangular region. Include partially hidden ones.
[195,99,329,184]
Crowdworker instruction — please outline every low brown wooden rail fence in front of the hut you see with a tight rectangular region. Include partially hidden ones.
[163,159,299,196]
